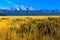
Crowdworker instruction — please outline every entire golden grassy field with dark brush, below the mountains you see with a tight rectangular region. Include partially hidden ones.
[0,16,60,40]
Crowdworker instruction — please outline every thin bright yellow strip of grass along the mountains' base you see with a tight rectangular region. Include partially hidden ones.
[0,16,60,19]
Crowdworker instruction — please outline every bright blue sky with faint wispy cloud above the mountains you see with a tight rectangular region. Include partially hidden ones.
[0,0,60,9]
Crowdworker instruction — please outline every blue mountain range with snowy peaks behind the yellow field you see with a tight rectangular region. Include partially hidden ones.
[0,6,60,15]
